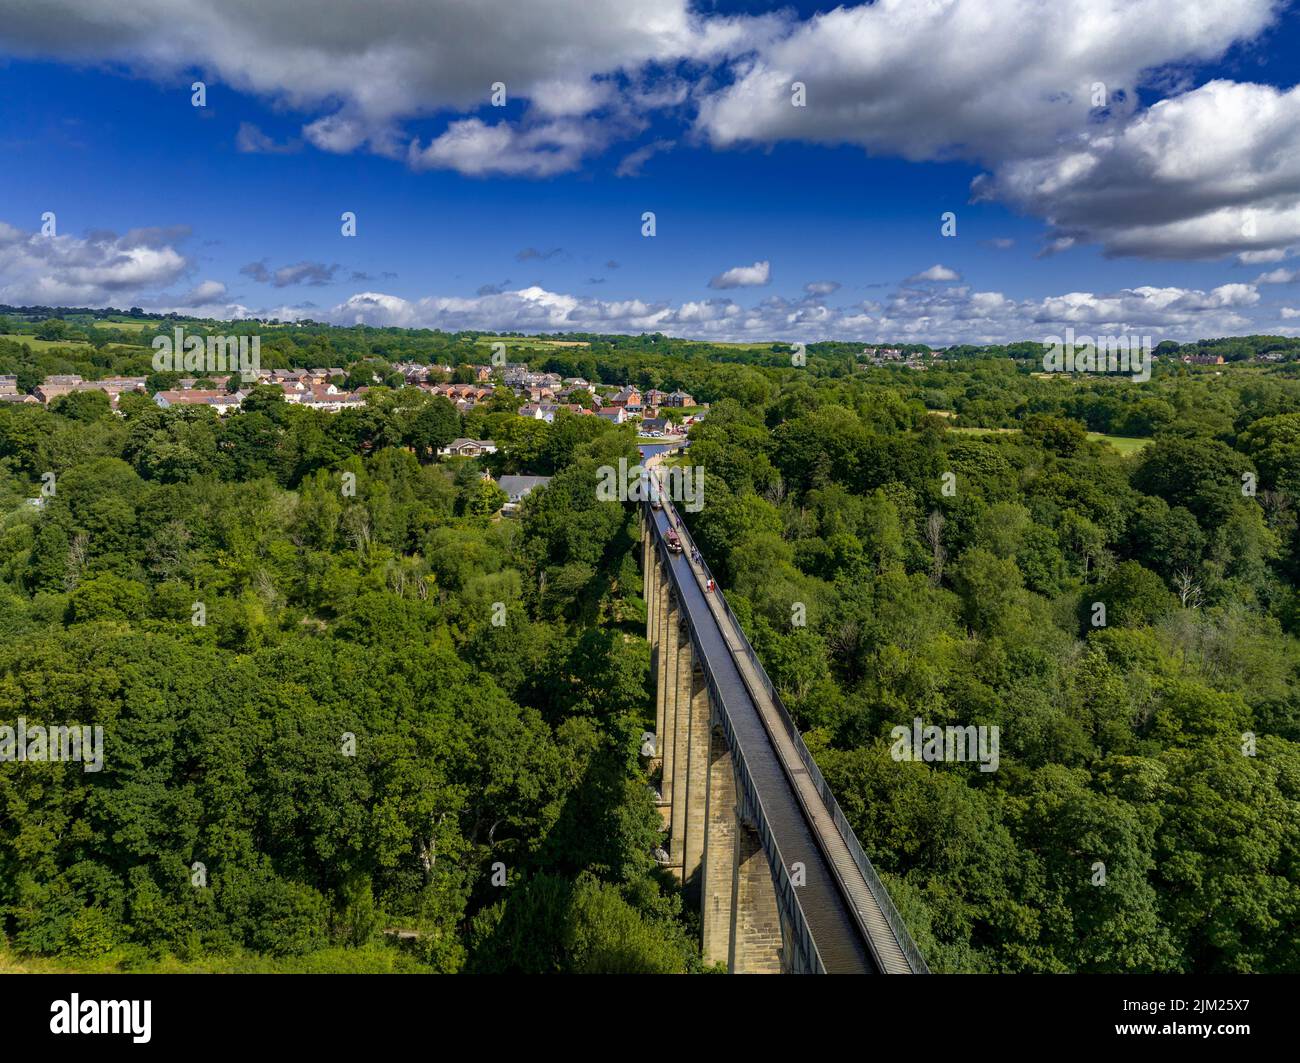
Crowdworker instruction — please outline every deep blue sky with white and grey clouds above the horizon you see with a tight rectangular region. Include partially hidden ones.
[0,0,1300,343]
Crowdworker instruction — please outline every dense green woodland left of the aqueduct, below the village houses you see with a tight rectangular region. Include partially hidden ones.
[0,358,698,971]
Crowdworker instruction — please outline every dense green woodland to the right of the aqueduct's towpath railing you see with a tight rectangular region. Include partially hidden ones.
[692,374,1300,972]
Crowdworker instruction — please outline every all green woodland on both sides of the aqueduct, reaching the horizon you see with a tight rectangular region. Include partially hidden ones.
[0,314,1300,972]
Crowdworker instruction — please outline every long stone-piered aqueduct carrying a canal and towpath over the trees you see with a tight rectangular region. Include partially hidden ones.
[641,473,927,973]
